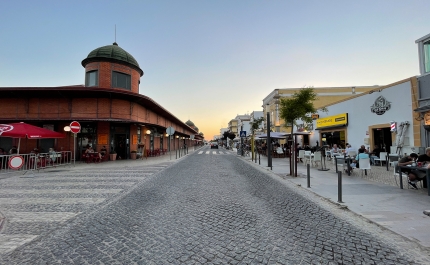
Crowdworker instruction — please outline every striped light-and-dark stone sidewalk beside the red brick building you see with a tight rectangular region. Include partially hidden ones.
[0,148,193,253]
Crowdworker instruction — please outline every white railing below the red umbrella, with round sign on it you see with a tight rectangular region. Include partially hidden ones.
[0,151,72,174]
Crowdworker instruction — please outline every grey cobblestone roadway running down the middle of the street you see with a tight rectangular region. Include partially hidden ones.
[0,146,425,264]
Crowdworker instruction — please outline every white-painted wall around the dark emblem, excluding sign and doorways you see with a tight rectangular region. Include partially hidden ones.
[310,81,413,149]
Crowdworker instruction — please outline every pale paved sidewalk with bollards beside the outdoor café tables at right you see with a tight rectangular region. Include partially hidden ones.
[233,150,430,249]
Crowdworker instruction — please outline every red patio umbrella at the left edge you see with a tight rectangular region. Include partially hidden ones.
[0,122,64,154]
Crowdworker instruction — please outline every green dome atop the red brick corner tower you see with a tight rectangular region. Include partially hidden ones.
[82,42,143,75]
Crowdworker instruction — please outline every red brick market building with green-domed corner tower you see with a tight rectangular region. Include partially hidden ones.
[0,43,203,159]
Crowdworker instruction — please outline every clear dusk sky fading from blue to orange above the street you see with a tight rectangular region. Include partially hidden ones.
[0,0,430,140]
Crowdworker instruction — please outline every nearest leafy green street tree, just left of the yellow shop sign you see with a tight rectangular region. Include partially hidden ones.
[279,87,327,175]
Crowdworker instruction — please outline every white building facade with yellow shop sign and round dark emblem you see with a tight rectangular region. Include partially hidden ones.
[310,77,422,154]
